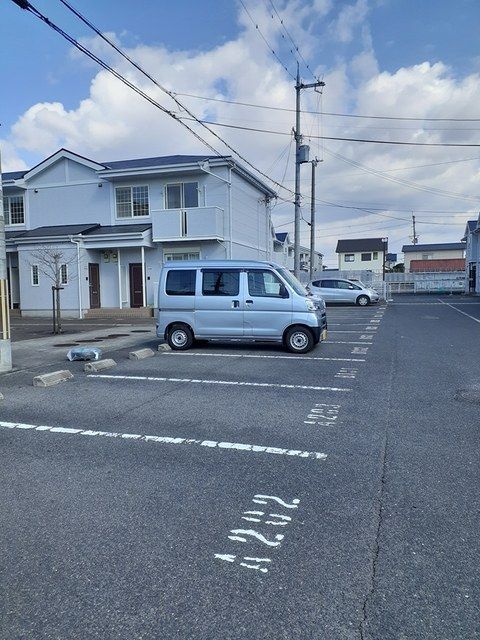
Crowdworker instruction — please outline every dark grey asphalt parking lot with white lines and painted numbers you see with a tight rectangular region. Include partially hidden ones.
[0,296,480,640]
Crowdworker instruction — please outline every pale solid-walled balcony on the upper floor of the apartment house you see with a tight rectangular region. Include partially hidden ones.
[152,207,224,242]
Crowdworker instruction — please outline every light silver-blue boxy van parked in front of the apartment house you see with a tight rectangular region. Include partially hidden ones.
[157,260,327,353]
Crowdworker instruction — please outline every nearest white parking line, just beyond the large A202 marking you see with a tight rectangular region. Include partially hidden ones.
[0,422,327,460]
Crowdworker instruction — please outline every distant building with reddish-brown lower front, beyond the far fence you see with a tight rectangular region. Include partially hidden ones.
[402,242,465,273]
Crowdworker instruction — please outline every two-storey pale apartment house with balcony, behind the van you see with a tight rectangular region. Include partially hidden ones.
[3,149,275,315]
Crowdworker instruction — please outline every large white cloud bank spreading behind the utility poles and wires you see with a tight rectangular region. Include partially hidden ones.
[2,0,480,265]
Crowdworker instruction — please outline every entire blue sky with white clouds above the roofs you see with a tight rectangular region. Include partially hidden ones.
[0,0,480,262]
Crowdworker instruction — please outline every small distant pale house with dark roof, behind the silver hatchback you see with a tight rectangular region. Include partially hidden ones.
[336,238,388,271]
